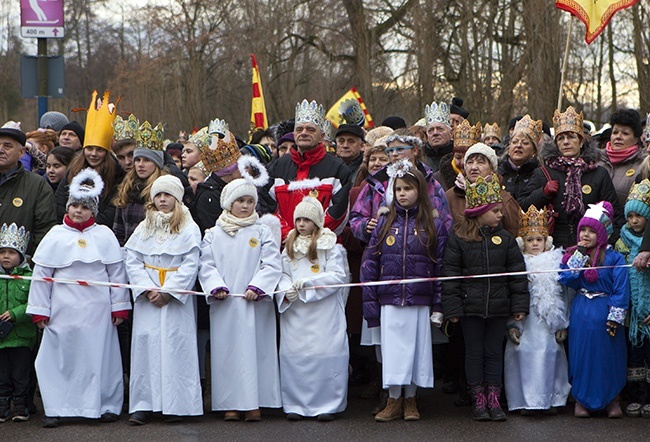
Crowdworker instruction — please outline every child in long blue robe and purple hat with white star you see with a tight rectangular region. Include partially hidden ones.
[560,201,630,418]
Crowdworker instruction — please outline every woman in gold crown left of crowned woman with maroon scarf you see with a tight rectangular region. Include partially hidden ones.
[499,115,542,202]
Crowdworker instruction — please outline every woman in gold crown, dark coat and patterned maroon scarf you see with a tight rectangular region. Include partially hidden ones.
[519,106,624,248]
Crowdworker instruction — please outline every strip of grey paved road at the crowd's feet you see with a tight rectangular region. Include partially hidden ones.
[0,388,650,442]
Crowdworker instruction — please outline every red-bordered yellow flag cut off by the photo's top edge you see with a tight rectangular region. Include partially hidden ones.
[555,0,639,44]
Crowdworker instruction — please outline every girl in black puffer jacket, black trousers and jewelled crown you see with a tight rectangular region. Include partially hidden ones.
[442,174,530,421]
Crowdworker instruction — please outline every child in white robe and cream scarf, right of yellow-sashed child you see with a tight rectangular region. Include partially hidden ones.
[199,178,282,422]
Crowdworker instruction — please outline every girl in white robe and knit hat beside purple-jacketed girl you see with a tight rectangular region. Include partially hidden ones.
[276,197,350,422]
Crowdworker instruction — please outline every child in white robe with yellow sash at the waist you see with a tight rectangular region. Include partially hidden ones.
[124,175,203,425]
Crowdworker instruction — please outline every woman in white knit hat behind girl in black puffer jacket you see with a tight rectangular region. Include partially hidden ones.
[447,143,521,236]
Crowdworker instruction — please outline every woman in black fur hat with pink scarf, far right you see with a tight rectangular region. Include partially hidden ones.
[600,109,648,207]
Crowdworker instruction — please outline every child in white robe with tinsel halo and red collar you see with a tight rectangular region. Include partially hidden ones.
[27,169,131,428]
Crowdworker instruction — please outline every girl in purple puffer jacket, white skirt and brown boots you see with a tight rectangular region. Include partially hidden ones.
[361,160,447,422]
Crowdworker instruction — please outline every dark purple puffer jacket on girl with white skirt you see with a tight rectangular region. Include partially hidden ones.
[361,203,448,327]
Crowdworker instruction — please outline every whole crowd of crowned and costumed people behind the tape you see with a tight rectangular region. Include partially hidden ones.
[0,92,650,428]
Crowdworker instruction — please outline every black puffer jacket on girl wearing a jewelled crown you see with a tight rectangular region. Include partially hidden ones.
[442,224,530,318]
